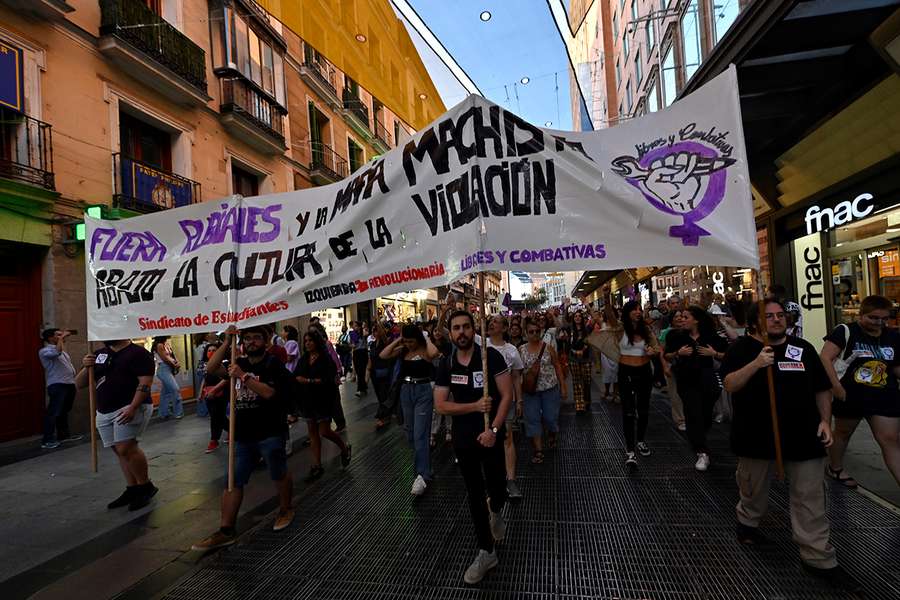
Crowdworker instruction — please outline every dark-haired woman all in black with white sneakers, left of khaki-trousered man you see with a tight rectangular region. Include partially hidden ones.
[665,306,728,471]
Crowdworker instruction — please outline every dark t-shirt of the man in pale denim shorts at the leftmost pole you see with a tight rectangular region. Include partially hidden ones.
[94,344,156,414]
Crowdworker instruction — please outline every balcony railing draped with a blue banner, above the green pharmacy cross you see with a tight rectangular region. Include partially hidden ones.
[113,153,200,213]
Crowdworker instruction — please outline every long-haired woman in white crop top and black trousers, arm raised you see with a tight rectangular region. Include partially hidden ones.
[601,290,659,471]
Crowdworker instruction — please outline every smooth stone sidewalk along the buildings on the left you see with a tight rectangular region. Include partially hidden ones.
[0,383,375,600]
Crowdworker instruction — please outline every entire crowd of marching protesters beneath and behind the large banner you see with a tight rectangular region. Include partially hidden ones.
[41,286,900,590]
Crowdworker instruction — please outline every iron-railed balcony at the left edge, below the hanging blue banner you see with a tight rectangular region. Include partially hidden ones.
[0,107,56,192]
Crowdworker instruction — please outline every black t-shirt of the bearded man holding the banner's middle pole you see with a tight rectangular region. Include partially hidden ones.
[434,344,509,448]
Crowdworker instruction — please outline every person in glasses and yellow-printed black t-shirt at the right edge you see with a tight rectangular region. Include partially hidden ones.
[822,296,900,488]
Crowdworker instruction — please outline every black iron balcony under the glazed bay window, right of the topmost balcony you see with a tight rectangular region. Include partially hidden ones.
[220,75,287,154]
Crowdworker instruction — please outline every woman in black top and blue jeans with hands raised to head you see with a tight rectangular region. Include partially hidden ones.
[379,324,438,496]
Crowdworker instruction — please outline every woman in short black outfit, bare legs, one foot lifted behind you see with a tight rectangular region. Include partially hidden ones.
[294,328,351,483]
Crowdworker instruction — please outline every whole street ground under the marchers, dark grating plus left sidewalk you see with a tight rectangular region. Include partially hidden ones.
[0,376,900,599]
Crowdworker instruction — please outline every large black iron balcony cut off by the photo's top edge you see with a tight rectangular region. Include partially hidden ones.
[99,0,209,105]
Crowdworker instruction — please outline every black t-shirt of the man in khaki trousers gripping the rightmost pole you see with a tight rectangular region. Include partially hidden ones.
[721,335,831,460]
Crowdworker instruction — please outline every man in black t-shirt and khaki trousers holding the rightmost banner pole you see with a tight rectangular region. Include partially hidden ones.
[721,300,859,591]
